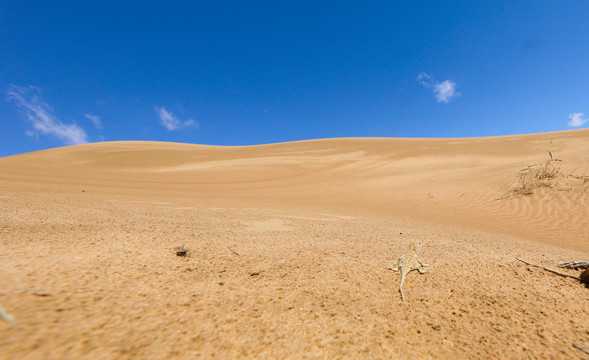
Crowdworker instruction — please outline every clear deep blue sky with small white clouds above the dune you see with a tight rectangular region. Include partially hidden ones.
[0,0,589,156]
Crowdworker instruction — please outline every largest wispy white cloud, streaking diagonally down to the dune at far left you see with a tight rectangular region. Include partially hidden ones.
[6,85,88,145]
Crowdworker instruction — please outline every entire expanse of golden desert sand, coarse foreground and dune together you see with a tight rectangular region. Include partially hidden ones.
[0,130,589,359]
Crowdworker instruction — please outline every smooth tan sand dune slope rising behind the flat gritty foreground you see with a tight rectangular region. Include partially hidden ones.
[0,130,589,252]
